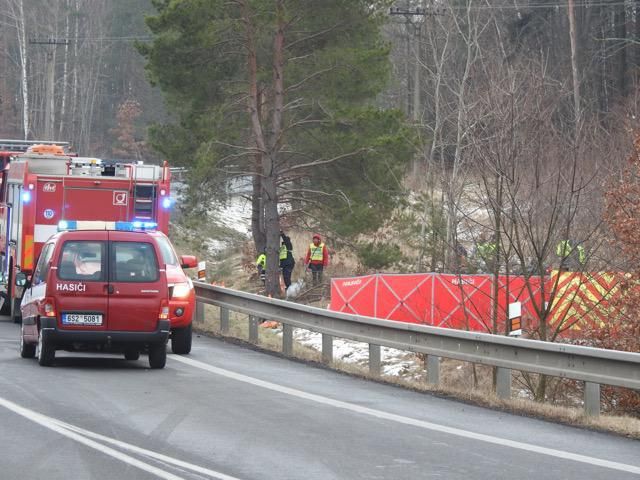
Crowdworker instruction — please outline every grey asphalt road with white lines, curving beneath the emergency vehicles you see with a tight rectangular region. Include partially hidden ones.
[0,320,640,480]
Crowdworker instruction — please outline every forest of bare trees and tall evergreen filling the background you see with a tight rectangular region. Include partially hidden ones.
[0,0,640,408]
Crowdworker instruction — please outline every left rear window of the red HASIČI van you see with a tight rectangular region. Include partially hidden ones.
[58,240,106,282]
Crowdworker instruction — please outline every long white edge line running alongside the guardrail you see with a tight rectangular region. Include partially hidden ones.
[170,355,640,475]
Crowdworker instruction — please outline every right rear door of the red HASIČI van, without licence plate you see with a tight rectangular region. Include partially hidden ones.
[108,232,168,332]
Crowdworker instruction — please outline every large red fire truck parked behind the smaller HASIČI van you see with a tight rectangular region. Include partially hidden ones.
[0,143,171,321]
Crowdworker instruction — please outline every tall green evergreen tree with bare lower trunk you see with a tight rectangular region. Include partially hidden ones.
[140,0,413,294]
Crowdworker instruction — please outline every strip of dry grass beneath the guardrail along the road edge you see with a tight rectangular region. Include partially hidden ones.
[195,305,640,439]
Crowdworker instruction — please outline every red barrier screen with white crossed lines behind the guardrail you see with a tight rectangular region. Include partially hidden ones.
[329,273,543,332]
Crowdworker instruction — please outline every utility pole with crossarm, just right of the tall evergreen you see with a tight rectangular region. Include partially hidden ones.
[389,3,439,123]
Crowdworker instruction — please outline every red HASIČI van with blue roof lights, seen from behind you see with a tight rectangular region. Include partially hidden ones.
[16,227,175,368]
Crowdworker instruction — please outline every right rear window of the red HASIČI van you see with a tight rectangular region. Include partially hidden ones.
[111,242,160,283]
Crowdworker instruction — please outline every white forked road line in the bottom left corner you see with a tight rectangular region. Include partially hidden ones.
[0,397,239,480]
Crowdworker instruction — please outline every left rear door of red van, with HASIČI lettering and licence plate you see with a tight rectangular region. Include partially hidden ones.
[55,232,109,330]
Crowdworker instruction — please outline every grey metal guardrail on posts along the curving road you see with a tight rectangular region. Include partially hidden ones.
[194,282,640,415]
